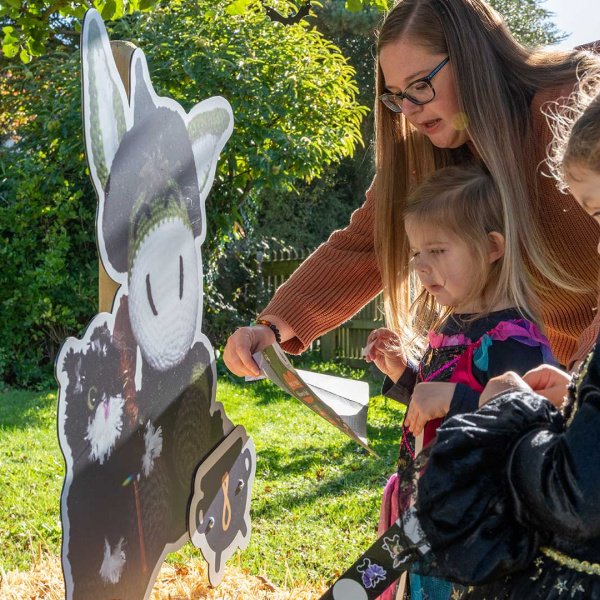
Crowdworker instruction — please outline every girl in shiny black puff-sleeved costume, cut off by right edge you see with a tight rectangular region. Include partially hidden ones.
[323,78,600,600]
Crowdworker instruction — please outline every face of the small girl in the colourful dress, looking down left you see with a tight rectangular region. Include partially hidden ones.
[405,217,494,313]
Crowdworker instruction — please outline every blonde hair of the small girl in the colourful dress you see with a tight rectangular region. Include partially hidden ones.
[399,164,541,360]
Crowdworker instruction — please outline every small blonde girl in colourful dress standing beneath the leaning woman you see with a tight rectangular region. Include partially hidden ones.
[366,165,552,600]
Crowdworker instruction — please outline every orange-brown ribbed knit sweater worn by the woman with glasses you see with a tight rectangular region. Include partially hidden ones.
[263,87,600,364]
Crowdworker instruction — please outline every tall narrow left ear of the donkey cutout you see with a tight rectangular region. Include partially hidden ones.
[81,9,131,189]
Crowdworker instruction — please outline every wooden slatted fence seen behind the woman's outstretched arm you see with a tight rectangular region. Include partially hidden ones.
[257,250,384,367]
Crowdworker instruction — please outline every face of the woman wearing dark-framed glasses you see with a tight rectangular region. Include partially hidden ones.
[379,39,469,148]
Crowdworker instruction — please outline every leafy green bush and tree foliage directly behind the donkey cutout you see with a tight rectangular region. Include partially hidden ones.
[0,0,365,385]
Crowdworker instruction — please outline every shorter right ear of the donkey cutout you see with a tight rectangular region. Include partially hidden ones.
[187,96,233,201]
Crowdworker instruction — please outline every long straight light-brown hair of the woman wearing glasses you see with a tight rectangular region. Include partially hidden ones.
[374,0,600,332]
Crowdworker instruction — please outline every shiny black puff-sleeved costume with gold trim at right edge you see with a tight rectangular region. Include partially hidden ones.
[402,332,600,600]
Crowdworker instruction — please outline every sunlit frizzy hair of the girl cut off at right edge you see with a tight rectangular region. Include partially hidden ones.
[547,73,600,193]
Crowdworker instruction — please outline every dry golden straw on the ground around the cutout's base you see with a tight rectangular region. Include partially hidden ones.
[0,557,325,600]
